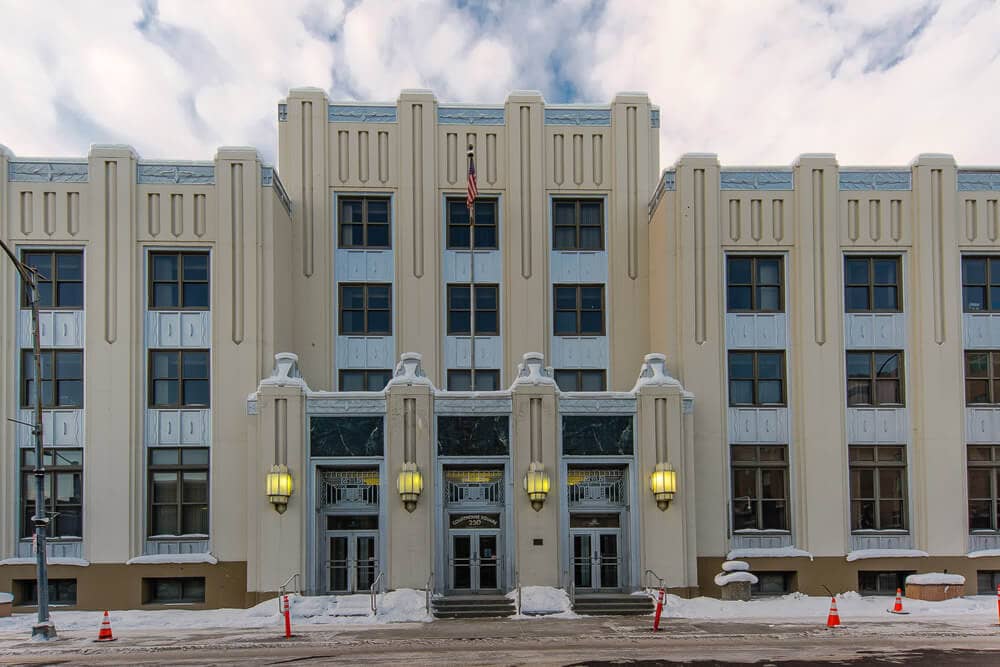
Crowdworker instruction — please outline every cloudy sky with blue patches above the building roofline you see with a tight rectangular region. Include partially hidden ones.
[0,0,1000,166]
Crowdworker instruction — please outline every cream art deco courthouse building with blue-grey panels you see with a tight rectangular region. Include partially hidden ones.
[0,89,1000,608]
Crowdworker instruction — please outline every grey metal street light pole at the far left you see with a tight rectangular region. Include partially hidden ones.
[0,240,56,639]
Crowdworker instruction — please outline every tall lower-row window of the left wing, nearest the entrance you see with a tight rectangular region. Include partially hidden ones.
[146,447,208,537]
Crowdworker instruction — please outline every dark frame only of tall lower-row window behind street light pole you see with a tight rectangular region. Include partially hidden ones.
[18,447,84,540]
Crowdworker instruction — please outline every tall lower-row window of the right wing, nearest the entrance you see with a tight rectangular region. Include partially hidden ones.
[730,445,788,531]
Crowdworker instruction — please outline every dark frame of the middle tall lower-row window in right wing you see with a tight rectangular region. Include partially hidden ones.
[847,445,910,535]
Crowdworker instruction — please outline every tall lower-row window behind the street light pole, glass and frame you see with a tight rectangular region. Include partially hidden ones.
[21,448,83,539]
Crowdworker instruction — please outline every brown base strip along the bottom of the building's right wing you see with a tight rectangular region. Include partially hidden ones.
[698,556,1000,597]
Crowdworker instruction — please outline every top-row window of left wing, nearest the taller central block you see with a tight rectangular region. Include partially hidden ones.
[149,252,209,310]
